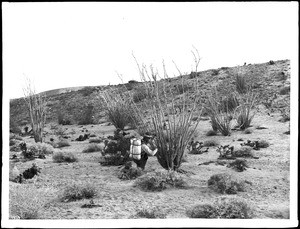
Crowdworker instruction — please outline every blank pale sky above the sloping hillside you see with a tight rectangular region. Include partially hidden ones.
[2,2,298,98]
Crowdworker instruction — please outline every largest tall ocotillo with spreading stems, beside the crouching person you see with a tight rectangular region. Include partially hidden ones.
[135,48,202,170]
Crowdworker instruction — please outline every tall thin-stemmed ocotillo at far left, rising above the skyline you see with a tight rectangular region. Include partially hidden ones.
[23,79,46,142]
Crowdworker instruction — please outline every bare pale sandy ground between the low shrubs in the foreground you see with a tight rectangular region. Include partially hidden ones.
[9,110,290,219]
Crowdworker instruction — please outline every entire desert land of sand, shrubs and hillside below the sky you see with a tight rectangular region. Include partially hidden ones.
[7,60,297,219]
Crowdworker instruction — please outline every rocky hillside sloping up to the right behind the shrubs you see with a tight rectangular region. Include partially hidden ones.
[10,60,290,131]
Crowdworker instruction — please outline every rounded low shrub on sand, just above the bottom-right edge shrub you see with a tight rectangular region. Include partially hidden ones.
[207,173,245,194]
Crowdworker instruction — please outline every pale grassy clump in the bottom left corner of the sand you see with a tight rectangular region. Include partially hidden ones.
[9,184,46,219]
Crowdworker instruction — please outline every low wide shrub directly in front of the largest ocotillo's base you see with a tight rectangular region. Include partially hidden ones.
[135,171,187,191]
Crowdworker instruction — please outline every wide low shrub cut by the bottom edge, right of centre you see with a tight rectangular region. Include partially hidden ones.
[186,197,253,219]
